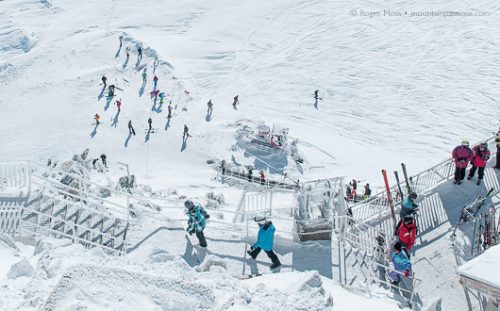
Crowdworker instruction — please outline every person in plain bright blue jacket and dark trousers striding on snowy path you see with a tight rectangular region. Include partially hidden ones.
[247,216,281,269]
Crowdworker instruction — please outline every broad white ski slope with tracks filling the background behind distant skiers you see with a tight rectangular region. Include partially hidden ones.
[0,1,500,190]
